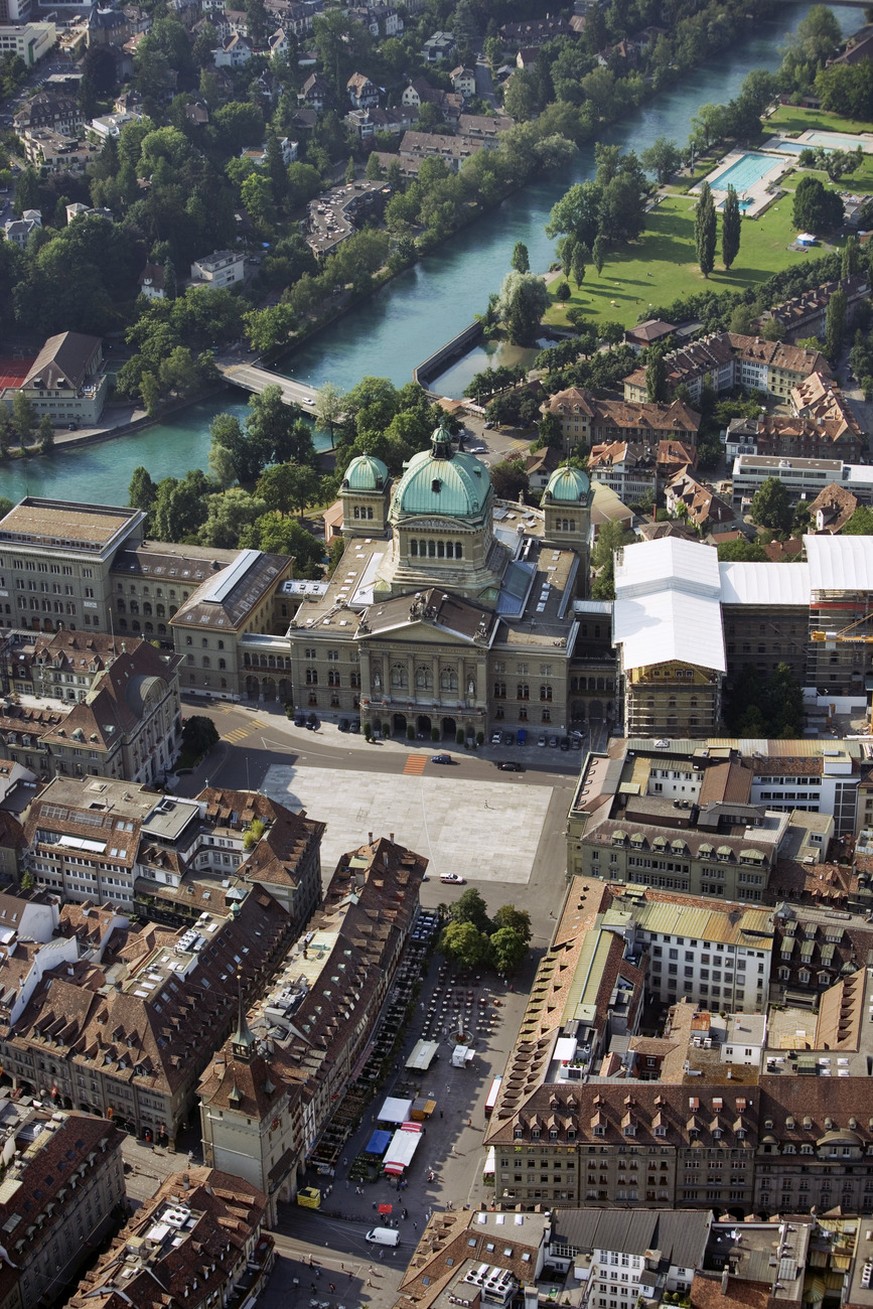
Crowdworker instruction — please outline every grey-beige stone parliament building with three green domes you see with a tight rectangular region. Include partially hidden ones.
[281,427,614,741]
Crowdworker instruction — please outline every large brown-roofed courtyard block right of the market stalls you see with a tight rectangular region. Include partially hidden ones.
[486,878,873,1215]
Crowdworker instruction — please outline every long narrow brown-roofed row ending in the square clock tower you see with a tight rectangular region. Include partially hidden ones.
[199,838,427,1217]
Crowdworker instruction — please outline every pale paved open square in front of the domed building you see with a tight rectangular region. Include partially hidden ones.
[260,763,552,886]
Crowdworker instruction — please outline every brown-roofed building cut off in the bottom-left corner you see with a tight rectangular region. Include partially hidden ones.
[0,1111,126,1309]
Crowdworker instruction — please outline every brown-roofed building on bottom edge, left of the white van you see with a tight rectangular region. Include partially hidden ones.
[67,1166,276,1309]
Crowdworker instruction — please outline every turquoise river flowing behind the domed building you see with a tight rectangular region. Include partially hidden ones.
[0,3,857,503]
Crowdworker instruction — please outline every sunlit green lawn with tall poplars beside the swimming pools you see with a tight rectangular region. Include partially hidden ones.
[544,106,873,327]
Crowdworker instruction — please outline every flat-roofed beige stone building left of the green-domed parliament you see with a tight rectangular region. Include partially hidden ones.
[0,496,294,699]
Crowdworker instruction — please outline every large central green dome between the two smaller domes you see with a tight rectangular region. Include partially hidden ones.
[391,424,491,521]
